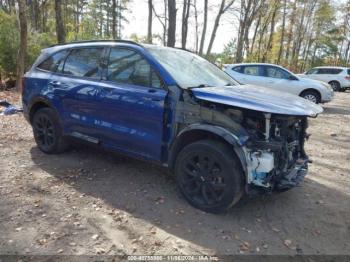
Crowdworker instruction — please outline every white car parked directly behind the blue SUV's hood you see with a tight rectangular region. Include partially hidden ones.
[224,63,334,103]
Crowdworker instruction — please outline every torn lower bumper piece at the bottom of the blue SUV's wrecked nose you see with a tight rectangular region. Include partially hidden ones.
[275,159,309,190]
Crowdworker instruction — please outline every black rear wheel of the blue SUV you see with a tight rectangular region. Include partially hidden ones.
[32,107,69,154]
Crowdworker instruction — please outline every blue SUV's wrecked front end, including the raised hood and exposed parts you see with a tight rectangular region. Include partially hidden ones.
[180,86,323,193]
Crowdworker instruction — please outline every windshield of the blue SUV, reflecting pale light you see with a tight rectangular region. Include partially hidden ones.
[147,46,238,89]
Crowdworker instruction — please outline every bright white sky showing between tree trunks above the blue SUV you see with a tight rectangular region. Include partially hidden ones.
[122,0,237,52]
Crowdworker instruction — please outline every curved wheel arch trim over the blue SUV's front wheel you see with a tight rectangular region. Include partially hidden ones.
[168,124,247,174]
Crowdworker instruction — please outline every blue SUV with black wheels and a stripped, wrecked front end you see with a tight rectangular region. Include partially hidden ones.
[23,41,322,213]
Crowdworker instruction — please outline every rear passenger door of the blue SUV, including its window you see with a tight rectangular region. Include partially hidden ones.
[49,47,104,137]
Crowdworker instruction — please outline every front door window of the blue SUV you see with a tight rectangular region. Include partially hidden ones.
[107,48,162,88]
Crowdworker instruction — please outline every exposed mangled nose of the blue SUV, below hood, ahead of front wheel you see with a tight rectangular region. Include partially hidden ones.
[243,113,309,191]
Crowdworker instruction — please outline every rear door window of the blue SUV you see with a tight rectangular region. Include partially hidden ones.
[63,48,103,79]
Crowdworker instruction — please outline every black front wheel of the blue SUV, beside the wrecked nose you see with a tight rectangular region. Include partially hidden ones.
[175,140,244,214]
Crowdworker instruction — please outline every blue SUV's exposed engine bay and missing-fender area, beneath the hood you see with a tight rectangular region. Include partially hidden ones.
[177,91,309,191]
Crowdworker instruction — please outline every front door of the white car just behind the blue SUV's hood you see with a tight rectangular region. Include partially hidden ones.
[262,65,300,95]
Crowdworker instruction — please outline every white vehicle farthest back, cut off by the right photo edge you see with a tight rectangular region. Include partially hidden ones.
[300,66,350,91]
